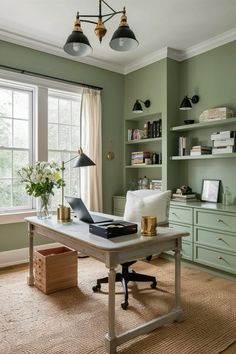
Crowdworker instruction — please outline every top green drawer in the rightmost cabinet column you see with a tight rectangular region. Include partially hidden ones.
[195,209,236,232]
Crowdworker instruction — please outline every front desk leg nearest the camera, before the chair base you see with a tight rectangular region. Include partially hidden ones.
[105,268,116,354]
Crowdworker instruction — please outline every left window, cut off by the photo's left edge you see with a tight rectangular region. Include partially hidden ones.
[0,80,34,211]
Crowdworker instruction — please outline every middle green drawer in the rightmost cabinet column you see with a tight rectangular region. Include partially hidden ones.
[194,227,236,252]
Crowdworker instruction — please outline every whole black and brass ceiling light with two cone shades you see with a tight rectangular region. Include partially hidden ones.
[63,0,139,57]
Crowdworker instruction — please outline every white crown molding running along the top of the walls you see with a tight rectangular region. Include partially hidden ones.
[0,28,236,75]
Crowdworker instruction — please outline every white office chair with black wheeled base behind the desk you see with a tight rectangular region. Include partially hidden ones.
[93,189,171,310]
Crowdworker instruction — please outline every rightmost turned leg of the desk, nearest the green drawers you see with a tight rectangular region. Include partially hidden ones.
[175,238,182,322]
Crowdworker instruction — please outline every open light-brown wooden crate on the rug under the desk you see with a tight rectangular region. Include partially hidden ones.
[34,246,77,294]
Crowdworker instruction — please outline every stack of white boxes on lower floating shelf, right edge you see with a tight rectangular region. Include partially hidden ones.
[211,130,236,154]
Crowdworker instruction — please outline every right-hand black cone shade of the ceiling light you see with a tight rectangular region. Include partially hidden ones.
[109,26,139,52]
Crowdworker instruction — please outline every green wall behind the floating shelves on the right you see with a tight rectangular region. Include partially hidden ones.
[179,41,236,203]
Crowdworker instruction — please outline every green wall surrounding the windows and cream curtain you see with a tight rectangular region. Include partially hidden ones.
[0,41,124,251]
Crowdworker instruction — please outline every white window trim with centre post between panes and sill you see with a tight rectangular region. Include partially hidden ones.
[0,69,82,224]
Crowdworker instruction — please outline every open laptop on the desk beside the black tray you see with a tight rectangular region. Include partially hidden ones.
[65,197,113,224]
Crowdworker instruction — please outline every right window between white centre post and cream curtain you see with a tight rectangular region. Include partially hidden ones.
[48,90,81,208]
